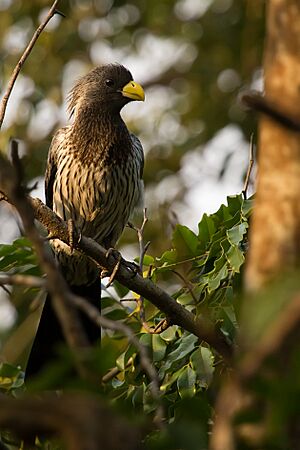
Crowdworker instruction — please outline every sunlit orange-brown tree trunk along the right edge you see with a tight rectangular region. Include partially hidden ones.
[246,0,300,291]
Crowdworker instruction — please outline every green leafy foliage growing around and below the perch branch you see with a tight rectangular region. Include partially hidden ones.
[0,195,252,449]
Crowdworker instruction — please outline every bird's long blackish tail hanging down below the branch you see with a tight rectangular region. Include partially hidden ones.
[26,280,101,379]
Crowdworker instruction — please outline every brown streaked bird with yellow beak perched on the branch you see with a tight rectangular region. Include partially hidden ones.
[26,64,145,378]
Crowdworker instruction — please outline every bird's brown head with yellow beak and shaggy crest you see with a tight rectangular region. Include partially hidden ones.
[68,64,145,115]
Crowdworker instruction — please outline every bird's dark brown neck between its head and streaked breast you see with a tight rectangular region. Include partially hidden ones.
[71,109,131,162]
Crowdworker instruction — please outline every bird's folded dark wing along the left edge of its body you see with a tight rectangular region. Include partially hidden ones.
[45,127,68,209]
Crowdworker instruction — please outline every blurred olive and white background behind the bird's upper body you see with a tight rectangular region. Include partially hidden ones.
[0,0,264,329]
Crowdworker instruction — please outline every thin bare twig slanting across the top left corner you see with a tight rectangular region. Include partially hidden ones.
[0,0,62,129]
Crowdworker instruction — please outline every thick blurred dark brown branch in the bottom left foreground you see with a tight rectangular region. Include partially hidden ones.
[0,394,142,450]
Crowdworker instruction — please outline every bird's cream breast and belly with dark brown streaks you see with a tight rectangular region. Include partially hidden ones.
[52,128,143,285]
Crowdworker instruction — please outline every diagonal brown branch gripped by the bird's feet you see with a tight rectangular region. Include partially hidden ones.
[29,197,233,362]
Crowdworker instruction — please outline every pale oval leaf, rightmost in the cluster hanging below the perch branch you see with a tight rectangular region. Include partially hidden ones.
[190,347,215,388]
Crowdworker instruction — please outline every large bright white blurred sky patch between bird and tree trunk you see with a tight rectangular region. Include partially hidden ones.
[178,125,253,229]
